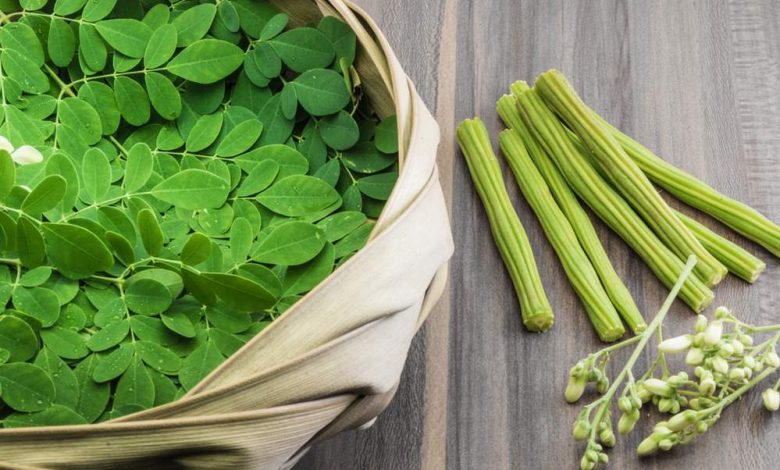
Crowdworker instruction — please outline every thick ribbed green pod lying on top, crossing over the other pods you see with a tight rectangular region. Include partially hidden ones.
[535,70,728,286]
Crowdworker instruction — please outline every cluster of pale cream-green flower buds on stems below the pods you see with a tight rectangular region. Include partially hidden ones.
[565,258,780,470]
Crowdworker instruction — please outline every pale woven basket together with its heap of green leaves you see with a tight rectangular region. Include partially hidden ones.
[0,0,452,468]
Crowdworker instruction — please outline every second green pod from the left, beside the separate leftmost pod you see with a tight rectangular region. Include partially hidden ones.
[499,129,626,341]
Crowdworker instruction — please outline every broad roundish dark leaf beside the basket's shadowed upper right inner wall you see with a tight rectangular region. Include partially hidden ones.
[292,69,350,116]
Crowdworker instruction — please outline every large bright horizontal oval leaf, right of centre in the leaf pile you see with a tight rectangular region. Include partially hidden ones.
[257,175,340,217]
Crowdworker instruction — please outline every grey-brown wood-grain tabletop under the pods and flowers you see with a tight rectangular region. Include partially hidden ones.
[299,0,780,470]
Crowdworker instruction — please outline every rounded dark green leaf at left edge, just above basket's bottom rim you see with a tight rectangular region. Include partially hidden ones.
[0,363,56,413]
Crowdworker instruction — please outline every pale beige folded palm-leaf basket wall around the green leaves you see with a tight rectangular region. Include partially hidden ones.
[0,0,453,470]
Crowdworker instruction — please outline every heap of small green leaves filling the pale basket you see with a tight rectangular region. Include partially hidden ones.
[0,0,398,427]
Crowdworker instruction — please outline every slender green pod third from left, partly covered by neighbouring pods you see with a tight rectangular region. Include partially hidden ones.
[496,81,647,333]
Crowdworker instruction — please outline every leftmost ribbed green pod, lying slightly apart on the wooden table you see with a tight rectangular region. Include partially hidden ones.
[457,118,554,332]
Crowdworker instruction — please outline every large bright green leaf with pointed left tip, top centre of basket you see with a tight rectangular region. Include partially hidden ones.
[168,39,244,85]
